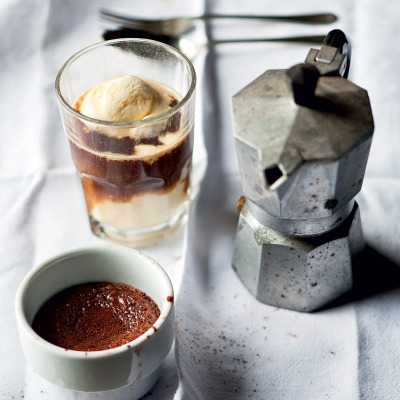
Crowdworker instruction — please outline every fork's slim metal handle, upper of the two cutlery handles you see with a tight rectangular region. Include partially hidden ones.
[198,13,337,24]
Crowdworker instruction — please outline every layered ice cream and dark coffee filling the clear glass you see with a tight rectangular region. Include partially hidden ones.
[68,75,193,243]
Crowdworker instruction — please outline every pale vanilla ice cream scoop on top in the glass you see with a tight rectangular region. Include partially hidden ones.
[79,75,157,122]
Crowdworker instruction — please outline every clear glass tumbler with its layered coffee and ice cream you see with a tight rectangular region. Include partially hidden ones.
[56,39,196,247]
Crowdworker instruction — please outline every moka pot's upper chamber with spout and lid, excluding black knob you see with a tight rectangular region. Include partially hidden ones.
[232,70,374,219]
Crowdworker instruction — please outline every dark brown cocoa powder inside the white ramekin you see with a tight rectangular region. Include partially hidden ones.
[32,282,161,351]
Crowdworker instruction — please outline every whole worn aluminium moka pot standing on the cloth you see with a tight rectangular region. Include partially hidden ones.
[232,30,374,312]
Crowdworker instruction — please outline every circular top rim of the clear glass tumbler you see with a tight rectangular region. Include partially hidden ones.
[55,38,197,128]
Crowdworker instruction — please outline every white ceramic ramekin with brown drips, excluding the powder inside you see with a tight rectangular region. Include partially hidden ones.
[15,245,174,399]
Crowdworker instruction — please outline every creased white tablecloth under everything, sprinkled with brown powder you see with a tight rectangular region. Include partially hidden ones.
[0,0,400,400]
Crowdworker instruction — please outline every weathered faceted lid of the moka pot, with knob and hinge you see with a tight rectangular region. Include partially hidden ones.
[232,30,374,191]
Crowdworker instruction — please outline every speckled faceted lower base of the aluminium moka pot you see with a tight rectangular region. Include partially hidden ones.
[232,203,364,312]
